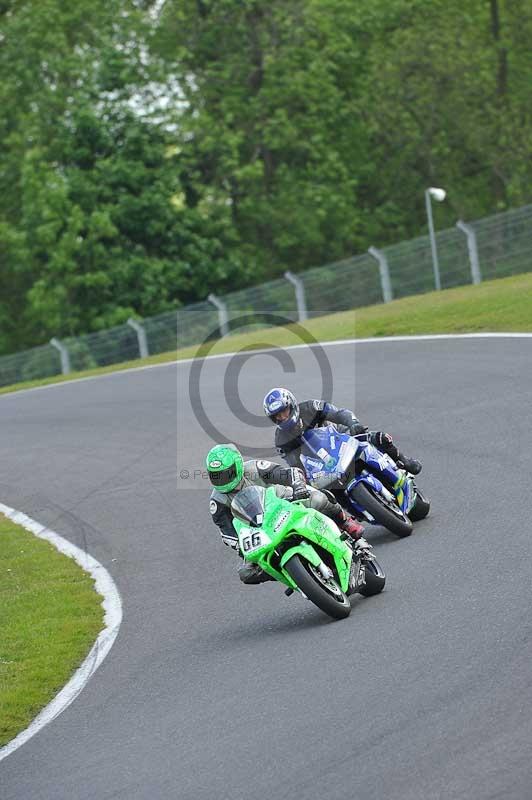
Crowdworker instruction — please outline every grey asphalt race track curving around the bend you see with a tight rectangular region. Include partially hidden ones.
[0,338,532,800]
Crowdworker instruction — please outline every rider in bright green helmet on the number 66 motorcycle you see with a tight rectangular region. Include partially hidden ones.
[206,444,369,583]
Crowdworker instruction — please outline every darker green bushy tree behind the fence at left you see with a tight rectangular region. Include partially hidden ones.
[16,109,239,337]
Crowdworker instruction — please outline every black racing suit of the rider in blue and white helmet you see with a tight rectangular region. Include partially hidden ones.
[275,400,402,467]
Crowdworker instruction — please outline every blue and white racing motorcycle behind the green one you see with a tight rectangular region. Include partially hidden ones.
[301,425,430,537]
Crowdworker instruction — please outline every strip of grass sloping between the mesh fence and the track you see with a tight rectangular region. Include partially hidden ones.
[0,273,532,394]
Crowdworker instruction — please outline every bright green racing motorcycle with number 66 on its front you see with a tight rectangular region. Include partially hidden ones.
[231,486,386,619]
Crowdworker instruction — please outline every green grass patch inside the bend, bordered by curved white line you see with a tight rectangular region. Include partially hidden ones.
[0,514,103,746]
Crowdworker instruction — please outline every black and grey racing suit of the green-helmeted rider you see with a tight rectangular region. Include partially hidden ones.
[209,460,345,550]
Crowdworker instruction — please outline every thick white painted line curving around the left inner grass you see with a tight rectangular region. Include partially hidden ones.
[0,503,122,761]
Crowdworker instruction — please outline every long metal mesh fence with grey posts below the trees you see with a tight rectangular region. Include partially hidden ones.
[0,200,532,386]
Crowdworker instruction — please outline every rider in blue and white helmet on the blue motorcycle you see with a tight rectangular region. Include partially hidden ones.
[263,388,421,475]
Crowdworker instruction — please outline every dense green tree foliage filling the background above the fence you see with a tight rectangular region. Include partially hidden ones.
[0,0,532,352]
